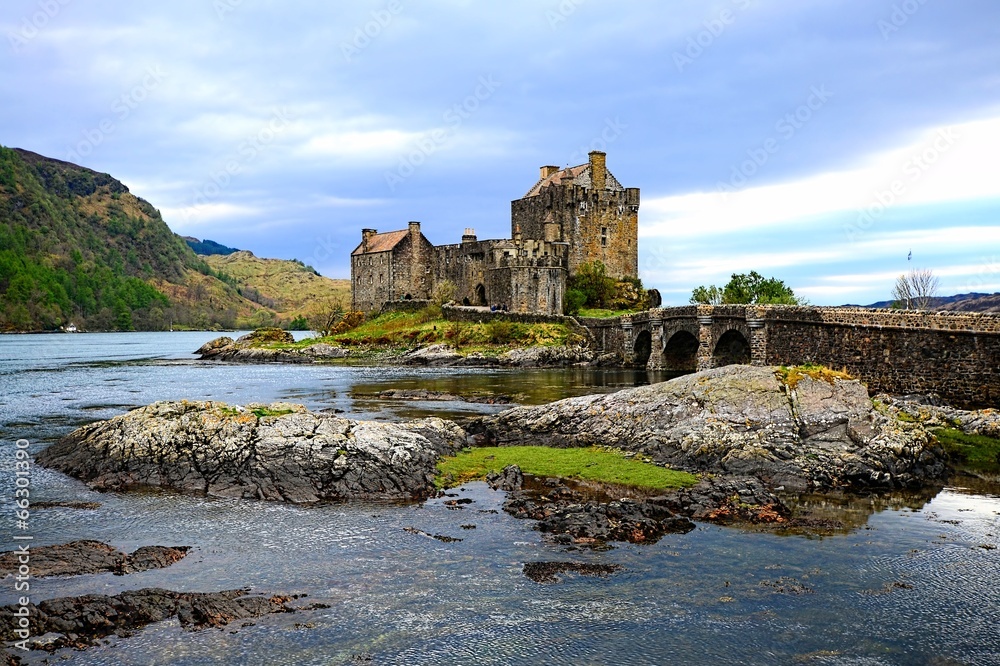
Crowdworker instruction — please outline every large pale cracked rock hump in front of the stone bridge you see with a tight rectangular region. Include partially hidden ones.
[466,365,946,489]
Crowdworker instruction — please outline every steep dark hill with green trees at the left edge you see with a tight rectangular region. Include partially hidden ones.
[0,146,340,331]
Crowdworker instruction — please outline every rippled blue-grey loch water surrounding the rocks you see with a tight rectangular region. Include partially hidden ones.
[0,333,1000,666]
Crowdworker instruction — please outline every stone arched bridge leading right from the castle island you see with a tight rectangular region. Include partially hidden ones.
[579,305,1000,407]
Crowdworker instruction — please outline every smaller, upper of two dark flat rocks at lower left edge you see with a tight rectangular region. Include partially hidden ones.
[0,541,190,578]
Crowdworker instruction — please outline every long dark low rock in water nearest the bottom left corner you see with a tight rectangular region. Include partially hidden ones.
[0,588,326,652]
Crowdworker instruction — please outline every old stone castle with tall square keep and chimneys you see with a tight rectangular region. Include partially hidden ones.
[351,151,639,314]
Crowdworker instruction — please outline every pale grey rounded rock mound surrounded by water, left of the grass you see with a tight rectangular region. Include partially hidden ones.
[38,401,465,502]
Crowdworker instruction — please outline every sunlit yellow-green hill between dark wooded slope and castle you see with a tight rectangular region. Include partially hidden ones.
[201,250,351,321]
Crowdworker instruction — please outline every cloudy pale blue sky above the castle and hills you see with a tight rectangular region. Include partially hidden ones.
[0,0,1000,305]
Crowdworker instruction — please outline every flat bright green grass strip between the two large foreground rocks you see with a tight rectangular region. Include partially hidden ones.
[437,446,698,490]
